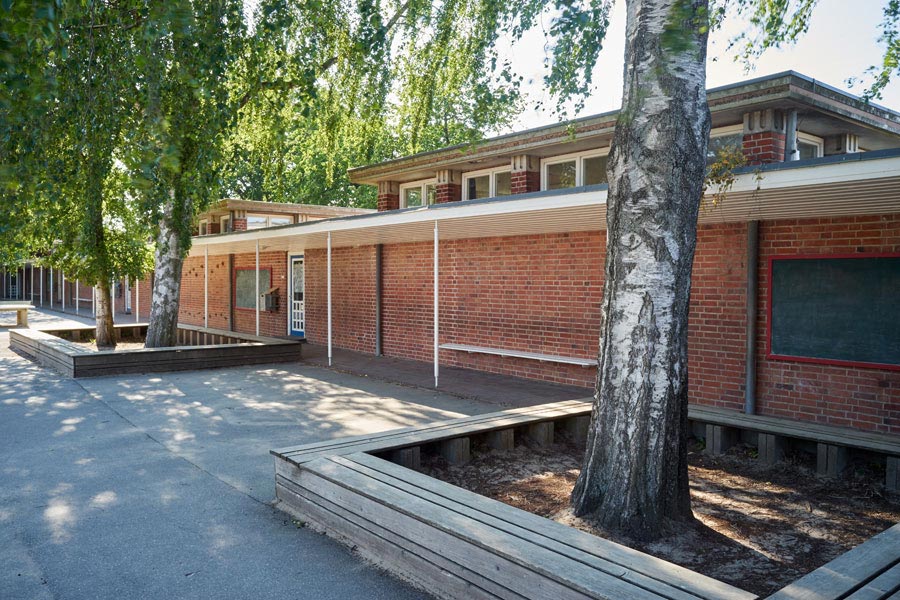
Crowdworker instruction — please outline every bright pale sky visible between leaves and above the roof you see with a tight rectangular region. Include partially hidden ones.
[498,0,900,133]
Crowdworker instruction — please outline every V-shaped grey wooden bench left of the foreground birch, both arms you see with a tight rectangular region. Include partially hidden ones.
[272,400,755,600]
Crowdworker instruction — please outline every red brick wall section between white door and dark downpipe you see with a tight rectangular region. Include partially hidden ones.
[304,246,375,353]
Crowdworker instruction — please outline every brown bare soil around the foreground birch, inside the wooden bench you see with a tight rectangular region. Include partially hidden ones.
[425,444,900,596]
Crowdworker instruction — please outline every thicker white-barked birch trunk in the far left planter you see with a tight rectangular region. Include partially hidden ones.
[144,192,190,348]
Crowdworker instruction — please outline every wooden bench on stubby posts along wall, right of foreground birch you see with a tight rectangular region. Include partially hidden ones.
[688,405,900,490]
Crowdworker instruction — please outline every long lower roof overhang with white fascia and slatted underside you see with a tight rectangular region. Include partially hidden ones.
[191,151,900,256]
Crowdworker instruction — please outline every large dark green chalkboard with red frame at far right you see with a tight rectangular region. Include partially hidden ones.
[769,256,900,368]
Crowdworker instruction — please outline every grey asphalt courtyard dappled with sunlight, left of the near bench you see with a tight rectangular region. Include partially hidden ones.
[0,312,524,600]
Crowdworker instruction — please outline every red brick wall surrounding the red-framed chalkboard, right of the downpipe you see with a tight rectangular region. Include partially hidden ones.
[757,215,900,434]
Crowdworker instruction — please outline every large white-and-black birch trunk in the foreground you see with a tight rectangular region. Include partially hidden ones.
[572,0,710,540]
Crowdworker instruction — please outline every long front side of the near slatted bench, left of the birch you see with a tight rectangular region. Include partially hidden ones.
[276,452,755,600]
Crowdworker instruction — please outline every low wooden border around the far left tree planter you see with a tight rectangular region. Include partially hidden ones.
[9,325,302,378]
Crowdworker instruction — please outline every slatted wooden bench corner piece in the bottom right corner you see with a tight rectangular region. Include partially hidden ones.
[769,524,900,600]
